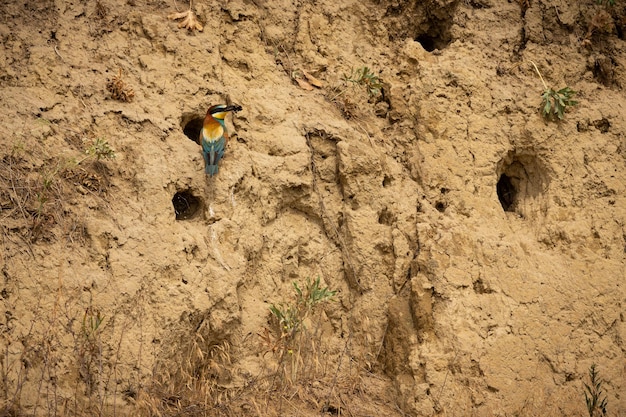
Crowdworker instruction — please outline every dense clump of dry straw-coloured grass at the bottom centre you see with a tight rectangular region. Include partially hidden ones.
[131,274,355,417]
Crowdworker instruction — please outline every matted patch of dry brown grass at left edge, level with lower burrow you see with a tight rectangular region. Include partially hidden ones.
[0,119,109,247]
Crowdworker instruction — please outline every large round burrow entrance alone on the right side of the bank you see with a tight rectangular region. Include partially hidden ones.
[496,151,550,218]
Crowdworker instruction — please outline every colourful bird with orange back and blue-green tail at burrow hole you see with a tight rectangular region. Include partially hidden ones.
[198,104,241,177]
